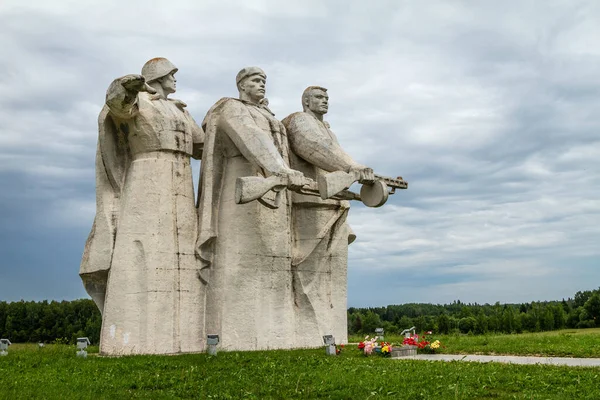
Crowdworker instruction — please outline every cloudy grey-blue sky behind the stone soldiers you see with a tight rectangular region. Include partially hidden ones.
[0,0,600,306]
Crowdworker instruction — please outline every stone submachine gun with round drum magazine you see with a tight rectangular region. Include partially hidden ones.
[318,171,408,207]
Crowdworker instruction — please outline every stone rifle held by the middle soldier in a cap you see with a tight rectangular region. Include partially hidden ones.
[235,175,361,208]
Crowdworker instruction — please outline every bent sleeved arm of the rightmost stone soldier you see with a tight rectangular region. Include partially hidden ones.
[288,115,367,172]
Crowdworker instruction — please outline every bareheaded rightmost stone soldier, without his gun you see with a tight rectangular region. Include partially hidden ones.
[283,86,373,347]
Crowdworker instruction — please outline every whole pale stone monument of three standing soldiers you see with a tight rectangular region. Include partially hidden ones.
[80,58,406,355]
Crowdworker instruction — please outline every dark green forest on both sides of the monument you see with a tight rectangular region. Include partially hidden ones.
[0,288,600,344]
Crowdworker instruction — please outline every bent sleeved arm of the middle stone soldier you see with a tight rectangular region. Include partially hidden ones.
[218,100,295,175]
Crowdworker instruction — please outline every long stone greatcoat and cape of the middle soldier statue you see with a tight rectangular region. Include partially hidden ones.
[197,98,294,350]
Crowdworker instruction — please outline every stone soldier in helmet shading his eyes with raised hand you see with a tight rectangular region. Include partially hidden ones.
[80,58,205,355]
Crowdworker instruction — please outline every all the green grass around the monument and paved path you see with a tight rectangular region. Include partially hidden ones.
[0,330,600,400]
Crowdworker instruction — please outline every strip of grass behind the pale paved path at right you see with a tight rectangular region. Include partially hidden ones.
[349,328,600,360]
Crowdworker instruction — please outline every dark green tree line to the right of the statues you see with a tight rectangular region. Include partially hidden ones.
[348,288,600,334]
